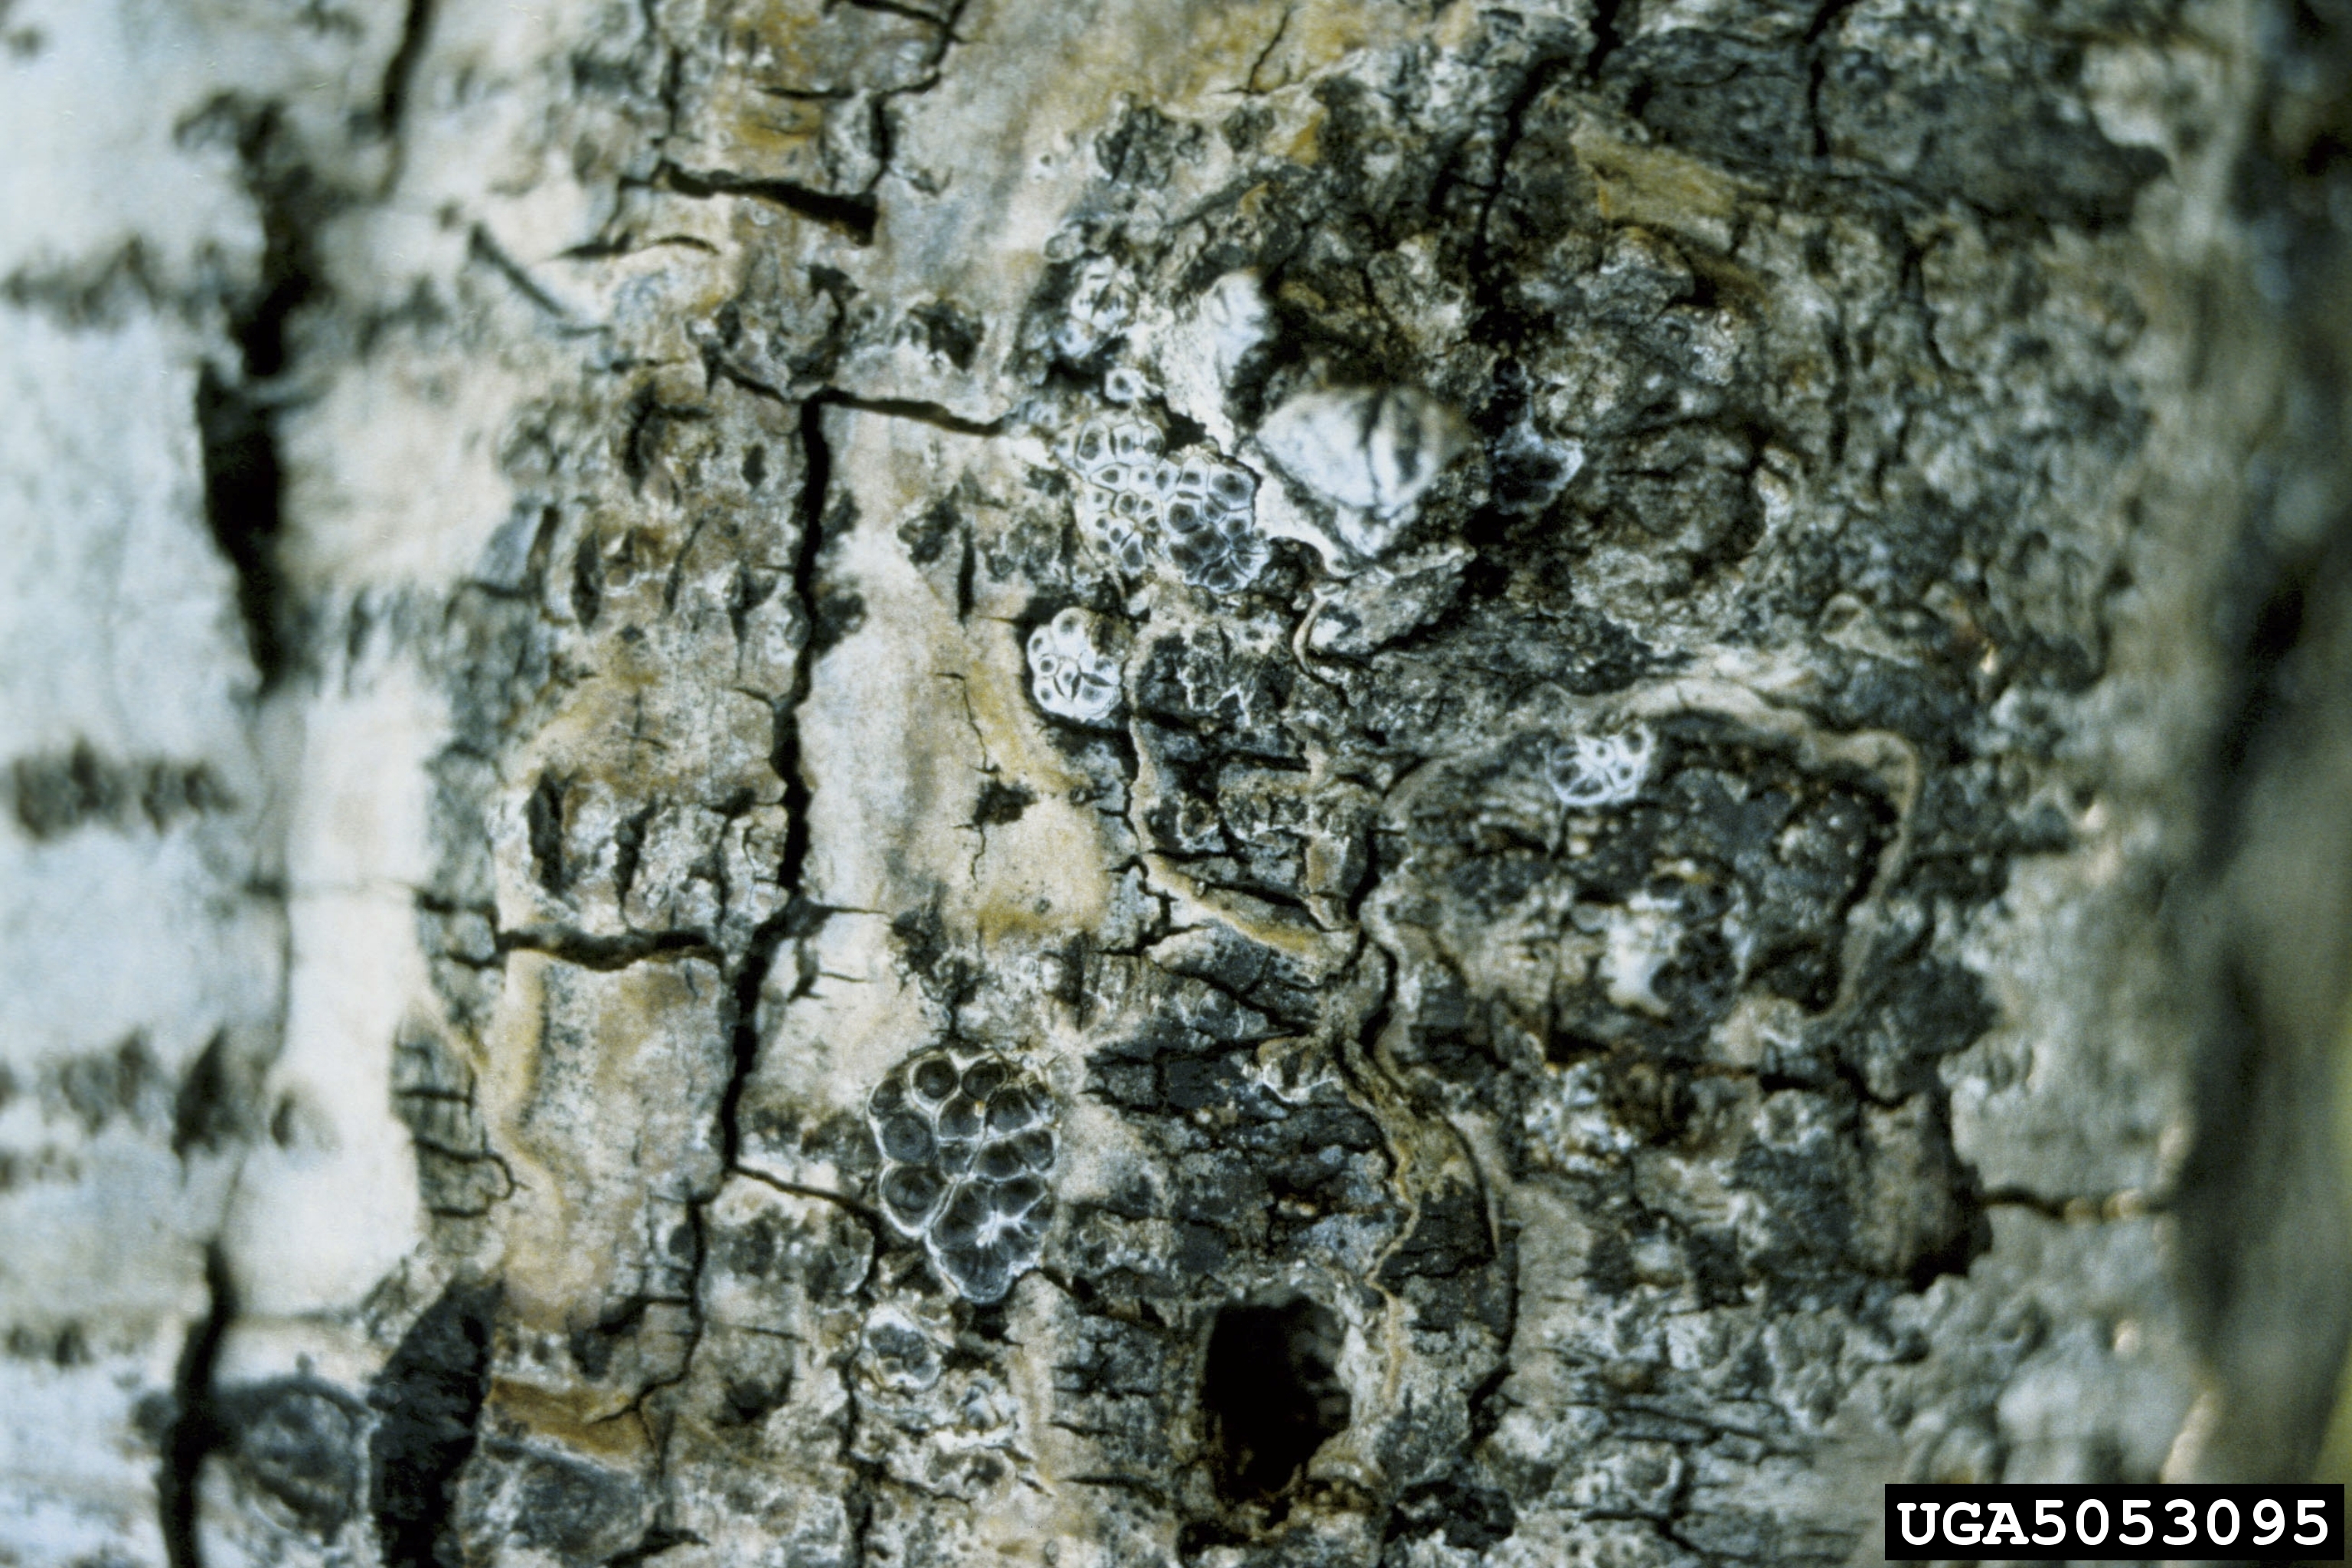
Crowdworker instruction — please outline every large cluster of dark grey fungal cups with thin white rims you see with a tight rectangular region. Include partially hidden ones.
[865,1050,1056,1305]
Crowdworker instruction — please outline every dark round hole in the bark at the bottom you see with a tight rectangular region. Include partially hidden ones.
[1200,1300,1352,1502]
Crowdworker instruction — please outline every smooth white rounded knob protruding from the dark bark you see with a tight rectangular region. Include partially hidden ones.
[1259,386,1465,555]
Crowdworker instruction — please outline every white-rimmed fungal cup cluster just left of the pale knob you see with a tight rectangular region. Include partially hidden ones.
[1063,419,1272,593]
